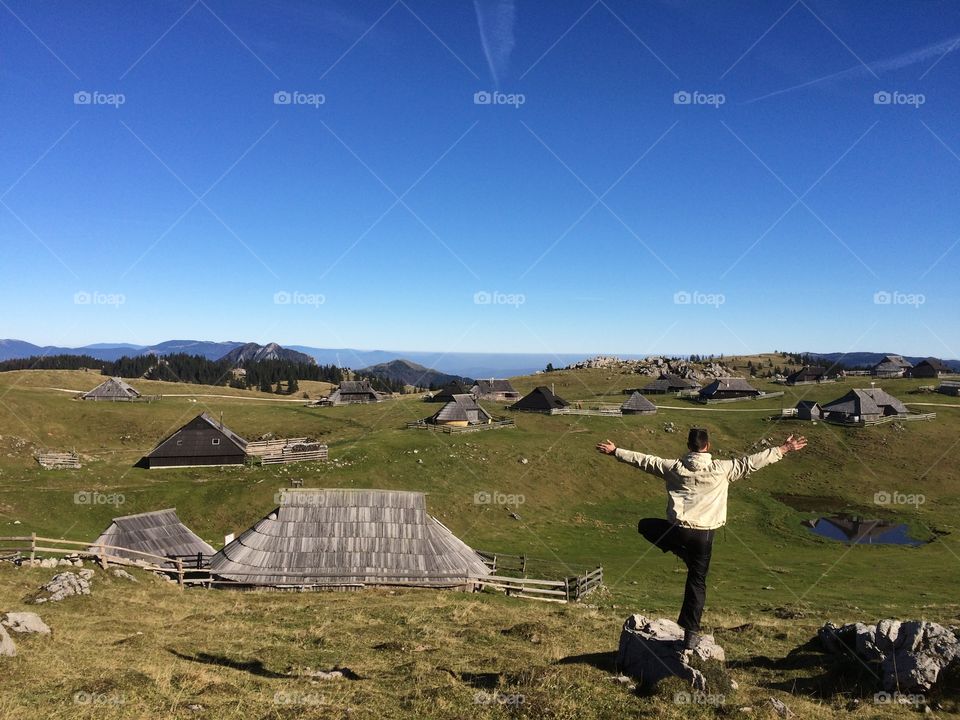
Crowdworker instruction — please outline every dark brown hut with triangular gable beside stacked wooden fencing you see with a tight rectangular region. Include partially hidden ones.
[143,413,247,469]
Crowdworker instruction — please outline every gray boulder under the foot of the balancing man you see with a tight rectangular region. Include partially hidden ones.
[617,615,726,692]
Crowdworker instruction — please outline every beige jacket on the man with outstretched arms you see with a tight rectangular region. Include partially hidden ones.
[615,447,783,530]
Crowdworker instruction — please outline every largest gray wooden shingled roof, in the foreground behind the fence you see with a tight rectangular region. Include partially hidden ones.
[210,489,489,587]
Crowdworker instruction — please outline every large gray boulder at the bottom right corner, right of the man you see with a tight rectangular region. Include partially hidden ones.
[818,620,960,693]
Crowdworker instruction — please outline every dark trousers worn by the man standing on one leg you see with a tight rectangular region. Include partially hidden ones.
[637,518,714,632]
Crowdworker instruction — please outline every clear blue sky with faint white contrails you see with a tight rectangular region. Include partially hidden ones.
[0,0,960,358]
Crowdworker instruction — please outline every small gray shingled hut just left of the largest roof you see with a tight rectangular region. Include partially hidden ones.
[90,508,216,567]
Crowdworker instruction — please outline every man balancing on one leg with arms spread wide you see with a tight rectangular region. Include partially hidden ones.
[597,428,807,650]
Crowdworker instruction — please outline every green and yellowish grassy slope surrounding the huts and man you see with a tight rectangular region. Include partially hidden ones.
[0,368,960,717]
